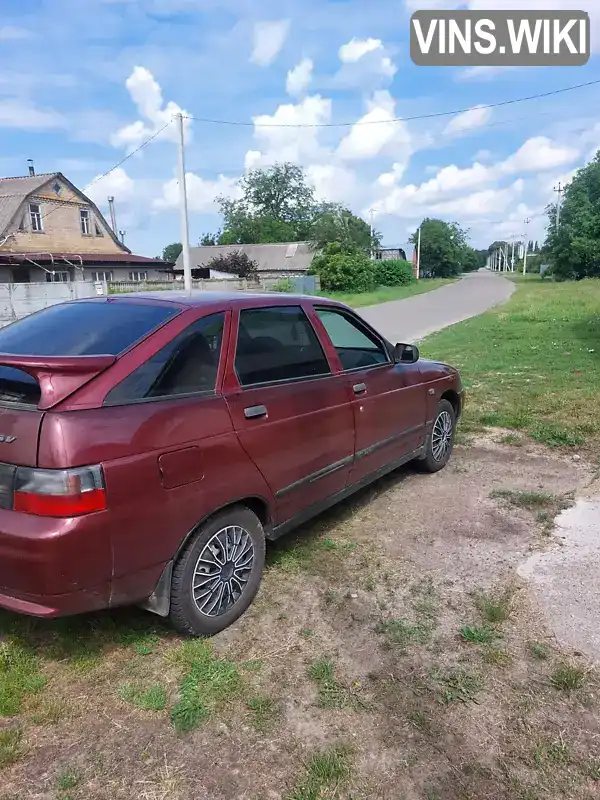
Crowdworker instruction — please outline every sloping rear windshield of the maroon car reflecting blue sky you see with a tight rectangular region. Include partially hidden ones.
[0,300,180,356]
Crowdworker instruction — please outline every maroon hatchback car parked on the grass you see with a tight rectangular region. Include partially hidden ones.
[0,292,463,635]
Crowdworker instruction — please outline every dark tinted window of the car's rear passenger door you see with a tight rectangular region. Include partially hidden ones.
[235,306,330,386]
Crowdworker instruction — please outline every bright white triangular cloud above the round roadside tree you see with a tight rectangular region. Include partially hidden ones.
[337,91,412,161]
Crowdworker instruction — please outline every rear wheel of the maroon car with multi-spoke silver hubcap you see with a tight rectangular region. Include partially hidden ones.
[169,506,265,636]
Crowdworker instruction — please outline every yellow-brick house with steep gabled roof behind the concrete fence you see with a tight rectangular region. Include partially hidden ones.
[0,166,172,283]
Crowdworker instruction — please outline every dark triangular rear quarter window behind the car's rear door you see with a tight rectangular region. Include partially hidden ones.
[104,313,225,405]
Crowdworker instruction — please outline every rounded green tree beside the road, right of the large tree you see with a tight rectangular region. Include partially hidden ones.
[410,218,471,278]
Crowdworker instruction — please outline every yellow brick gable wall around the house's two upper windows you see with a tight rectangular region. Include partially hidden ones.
[0,180,125,253]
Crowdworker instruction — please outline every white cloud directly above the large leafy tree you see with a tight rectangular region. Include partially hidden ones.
[245,94,331,166]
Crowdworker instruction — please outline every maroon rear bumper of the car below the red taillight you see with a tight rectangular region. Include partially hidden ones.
[0,509,112,617]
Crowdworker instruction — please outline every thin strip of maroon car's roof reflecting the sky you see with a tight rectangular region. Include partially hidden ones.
[75,289,342,308]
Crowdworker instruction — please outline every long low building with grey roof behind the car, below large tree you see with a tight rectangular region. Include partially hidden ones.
[173,242,316,278]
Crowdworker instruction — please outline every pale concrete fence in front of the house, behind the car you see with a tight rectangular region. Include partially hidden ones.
[0,281,106,327]
